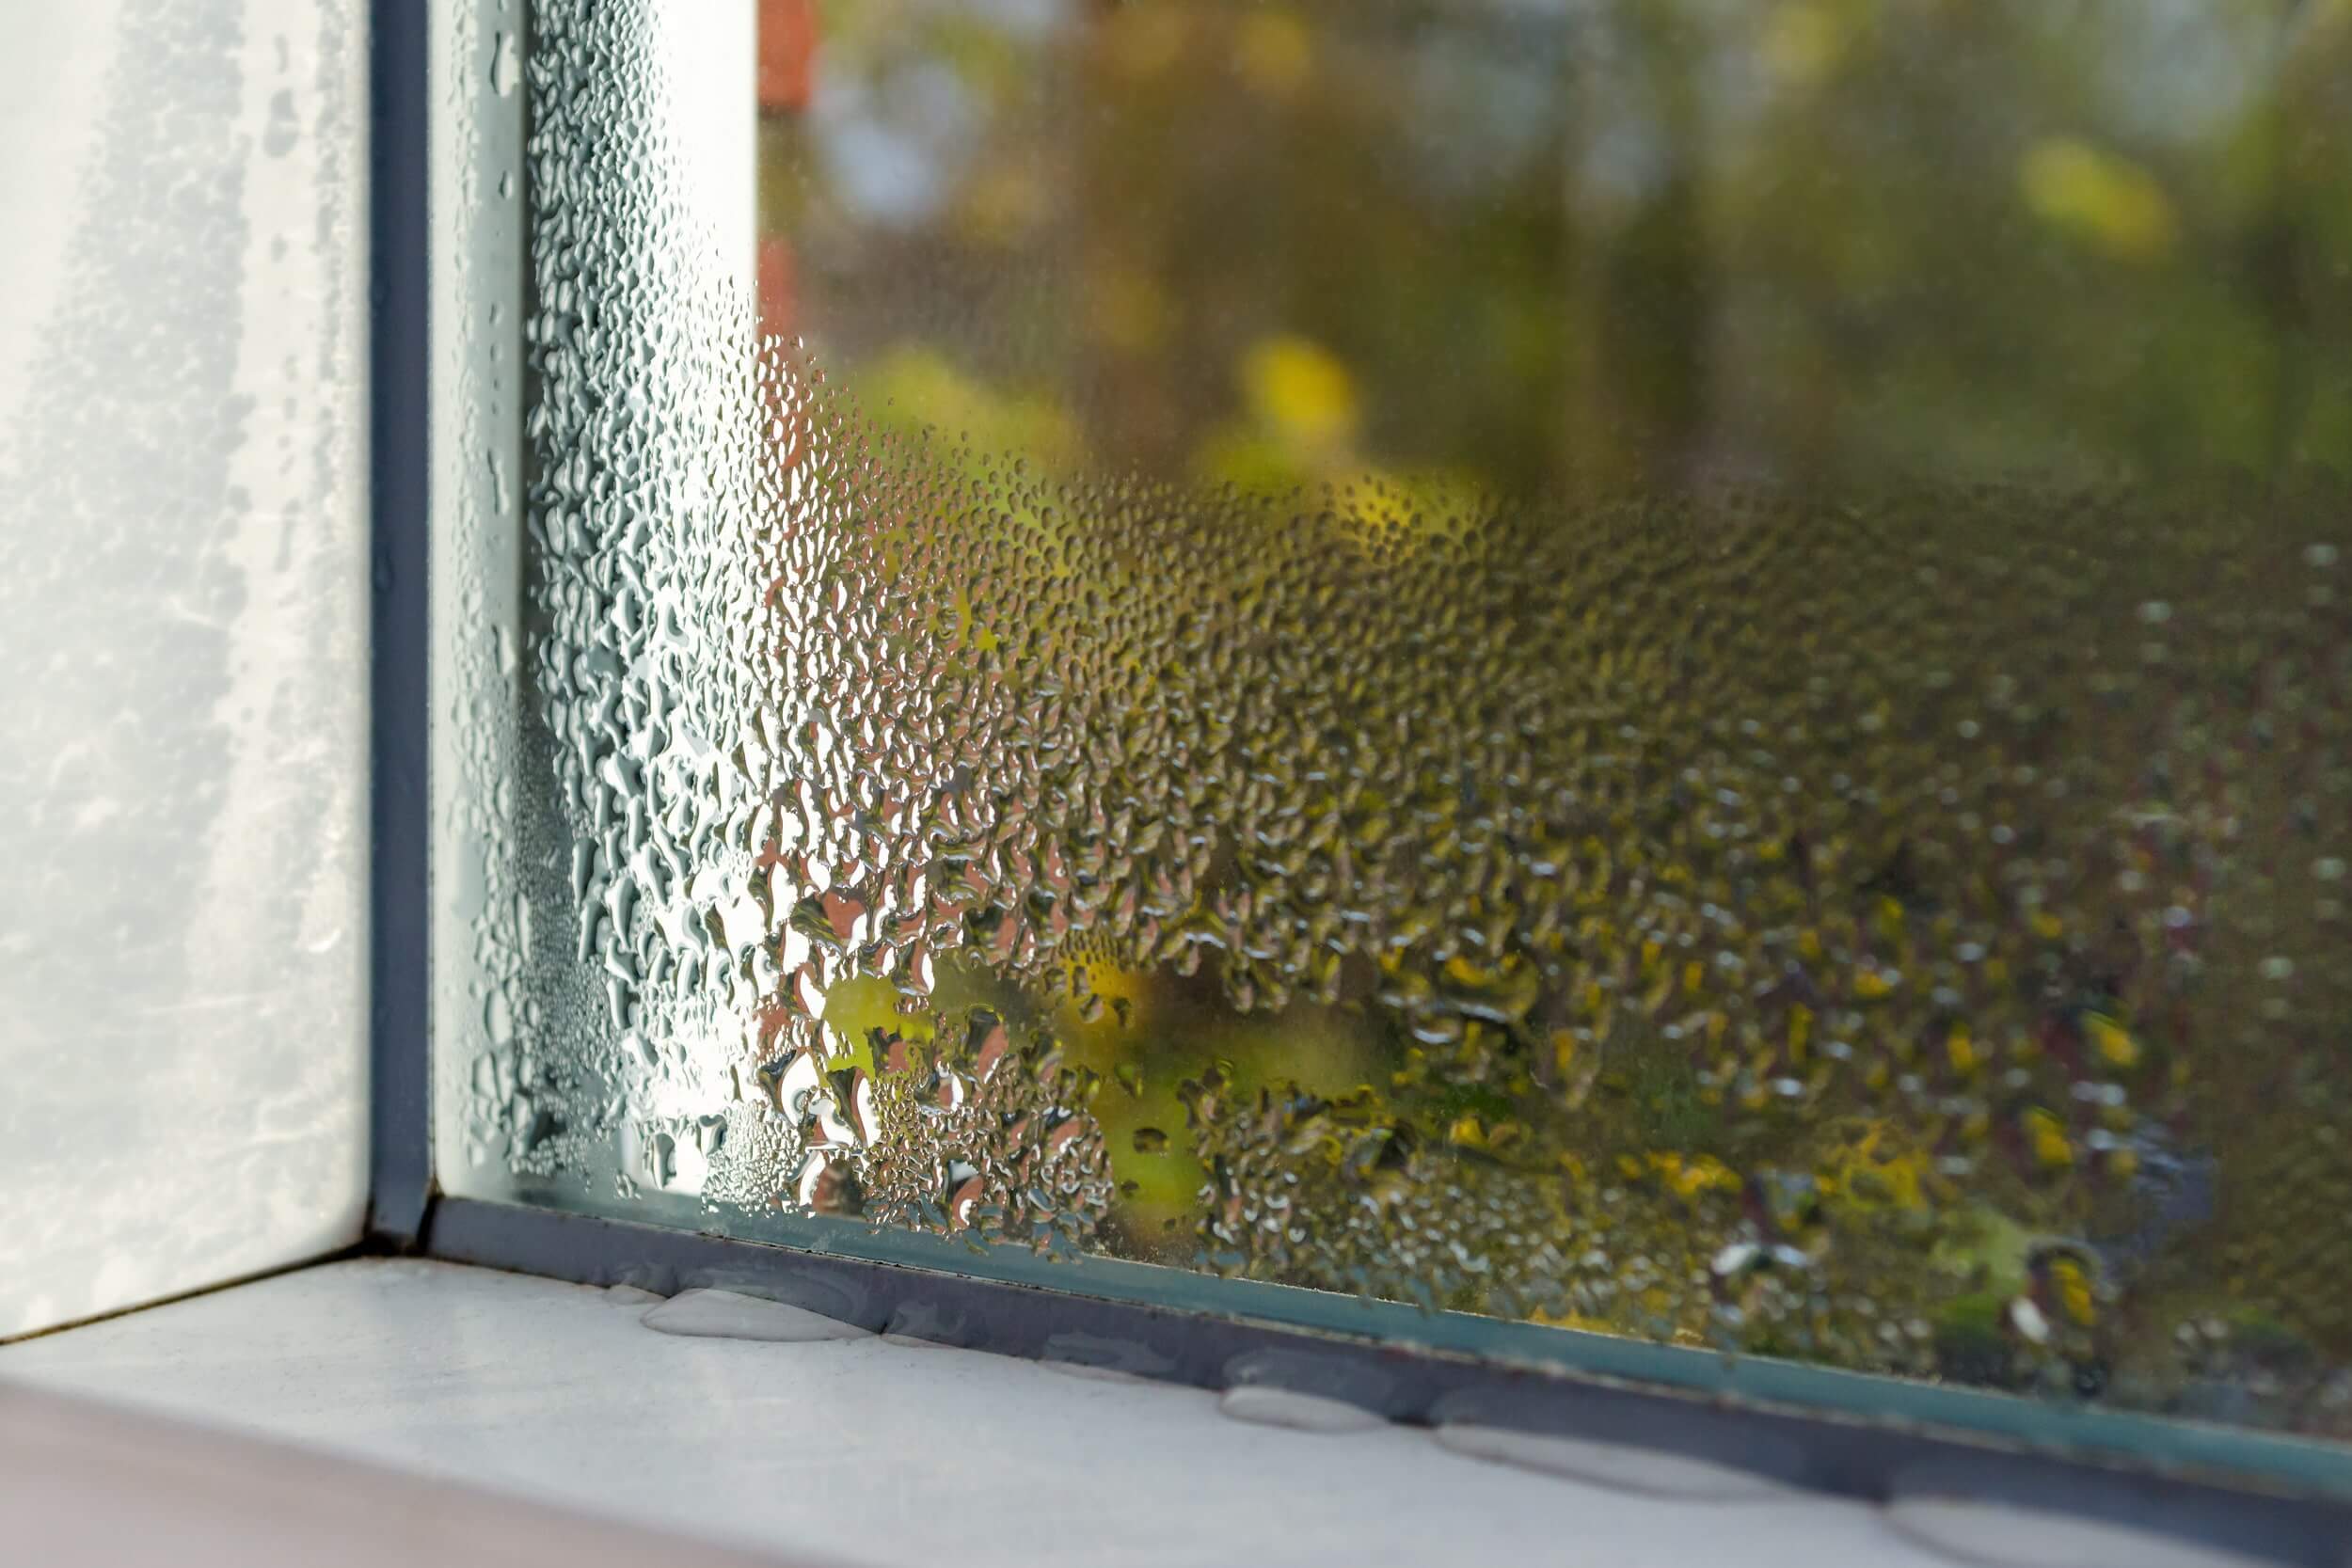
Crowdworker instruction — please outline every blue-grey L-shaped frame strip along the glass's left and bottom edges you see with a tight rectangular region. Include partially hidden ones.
[367,0,2352,1563]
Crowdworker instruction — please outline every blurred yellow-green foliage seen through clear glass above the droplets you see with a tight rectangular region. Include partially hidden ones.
[762,0,2352,491]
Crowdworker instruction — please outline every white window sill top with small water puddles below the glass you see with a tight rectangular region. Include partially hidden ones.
[0,1260,2249,1568]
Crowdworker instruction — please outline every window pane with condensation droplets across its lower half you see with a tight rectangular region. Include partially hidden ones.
[445,0,2352,1434]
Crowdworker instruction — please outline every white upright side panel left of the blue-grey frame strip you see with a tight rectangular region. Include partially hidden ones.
[0,0,370,1354]
